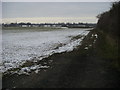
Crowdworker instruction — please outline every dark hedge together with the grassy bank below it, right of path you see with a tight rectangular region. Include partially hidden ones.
[96,1,120,69]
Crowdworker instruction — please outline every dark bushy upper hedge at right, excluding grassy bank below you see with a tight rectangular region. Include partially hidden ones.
[97,1,120,37]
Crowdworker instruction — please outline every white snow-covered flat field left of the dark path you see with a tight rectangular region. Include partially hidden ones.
[0,29,89,72]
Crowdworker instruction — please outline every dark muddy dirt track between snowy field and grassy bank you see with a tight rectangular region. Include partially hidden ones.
[3,30,120,88]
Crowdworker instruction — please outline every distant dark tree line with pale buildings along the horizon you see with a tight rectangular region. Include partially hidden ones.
[2,22,96,28]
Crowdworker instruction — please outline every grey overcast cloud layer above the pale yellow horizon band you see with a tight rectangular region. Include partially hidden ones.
[2,2,111,23]
